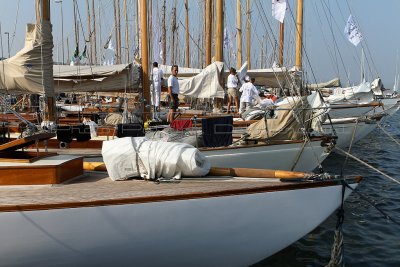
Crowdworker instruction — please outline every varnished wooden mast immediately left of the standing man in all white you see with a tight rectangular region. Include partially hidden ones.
[140,0,150,121]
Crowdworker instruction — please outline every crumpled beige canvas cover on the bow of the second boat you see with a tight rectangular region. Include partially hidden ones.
[247,97,312,140]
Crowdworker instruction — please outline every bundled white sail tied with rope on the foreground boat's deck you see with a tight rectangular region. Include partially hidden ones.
[101,137,211,181]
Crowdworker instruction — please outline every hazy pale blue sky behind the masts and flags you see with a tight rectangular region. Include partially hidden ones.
[0,0,400,88]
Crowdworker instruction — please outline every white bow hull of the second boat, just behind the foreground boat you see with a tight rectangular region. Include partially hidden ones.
[202,141,329,172]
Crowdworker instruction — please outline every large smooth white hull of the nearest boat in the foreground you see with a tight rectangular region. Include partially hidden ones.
[0,184,356,267]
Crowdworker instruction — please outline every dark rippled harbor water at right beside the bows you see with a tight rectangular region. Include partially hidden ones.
[253,112,400,267]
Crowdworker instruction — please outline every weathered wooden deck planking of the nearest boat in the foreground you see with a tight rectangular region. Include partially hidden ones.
[0,172,344,212]
